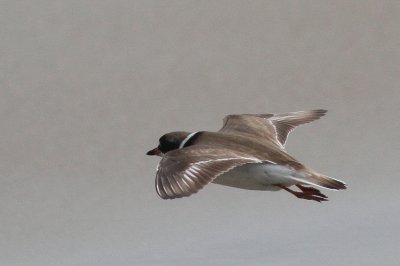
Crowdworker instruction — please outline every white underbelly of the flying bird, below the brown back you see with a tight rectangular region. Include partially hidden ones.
[213,163,301,191]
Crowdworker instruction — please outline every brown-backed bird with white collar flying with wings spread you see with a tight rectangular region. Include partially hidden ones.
[147,109,346,202]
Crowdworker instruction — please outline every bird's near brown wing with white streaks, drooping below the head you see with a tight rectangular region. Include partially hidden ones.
[156,145,262,199]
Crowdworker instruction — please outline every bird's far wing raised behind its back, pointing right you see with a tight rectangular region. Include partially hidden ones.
[219,109,327,148]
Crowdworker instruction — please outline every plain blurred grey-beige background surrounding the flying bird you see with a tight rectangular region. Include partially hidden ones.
[0,0,400,265]
